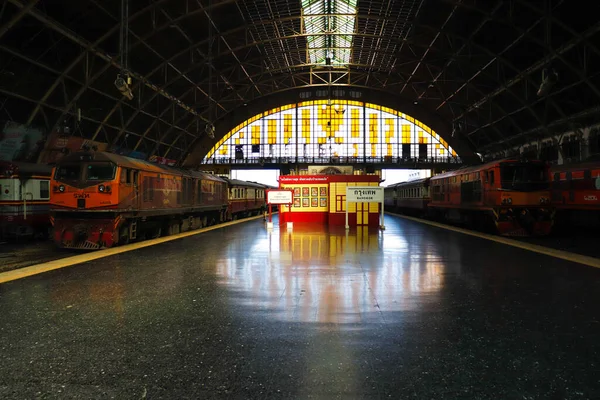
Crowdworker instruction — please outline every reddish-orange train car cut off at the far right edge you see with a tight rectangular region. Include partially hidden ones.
[550,160,600,226]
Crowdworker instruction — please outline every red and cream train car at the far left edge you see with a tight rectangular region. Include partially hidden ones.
[0,161,52,239]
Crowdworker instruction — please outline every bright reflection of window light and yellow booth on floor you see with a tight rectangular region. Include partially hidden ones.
[216,224,443,324]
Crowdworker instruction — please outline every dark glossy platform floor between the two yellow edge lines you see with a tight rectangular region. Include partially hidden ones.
[0,216,600,399]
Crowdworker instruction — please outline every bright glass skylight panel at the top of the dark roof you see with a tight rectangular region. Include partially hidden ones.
[301,0,358,65]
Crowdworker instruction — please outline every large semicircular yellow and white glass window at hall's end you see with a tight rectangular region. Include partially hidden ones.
[205,100,457,162]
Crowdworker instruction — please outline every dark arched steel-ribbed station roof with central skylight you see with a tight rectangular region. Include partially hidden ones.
[0,0,600,162]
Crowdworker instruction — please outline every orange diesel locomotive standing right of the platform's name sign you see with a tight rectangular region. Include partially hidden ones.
[428,159,554,236]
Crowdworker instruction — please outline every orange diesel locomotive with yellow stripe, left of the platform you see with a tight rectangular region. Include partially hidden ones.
[50,152,228,250]
